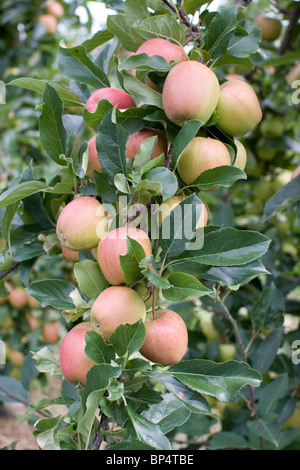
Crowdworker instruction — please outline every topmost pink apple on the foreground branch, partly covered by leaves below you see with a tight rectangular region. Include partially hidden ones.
[132,38,187,92]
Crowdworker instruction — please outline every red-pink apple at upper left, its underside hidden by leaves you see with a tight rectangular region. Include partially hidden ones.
[86,87,136,113]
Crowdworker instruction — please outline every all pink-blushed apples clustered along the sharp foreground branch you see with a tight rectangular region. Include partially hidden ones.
[56,38,262,383]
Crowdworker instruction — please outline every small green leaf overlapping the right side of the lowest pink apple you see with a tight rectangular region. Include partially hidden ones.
[85,331,115,364]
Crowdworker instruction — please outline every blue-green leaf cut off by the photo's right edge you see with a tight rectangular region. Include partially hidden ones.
[262,175,300,223]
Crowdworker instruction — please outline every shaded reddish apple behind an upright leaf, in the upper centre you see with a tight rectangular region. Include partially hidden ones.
[126,127,168,160]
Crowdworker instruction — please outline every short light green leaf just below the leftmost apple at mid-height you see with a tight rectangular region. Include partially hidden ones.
[74,259,108,299]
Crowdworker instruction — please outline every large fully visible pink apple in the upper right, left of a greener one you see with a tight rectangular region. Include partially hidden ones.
[162,60,220,126]
